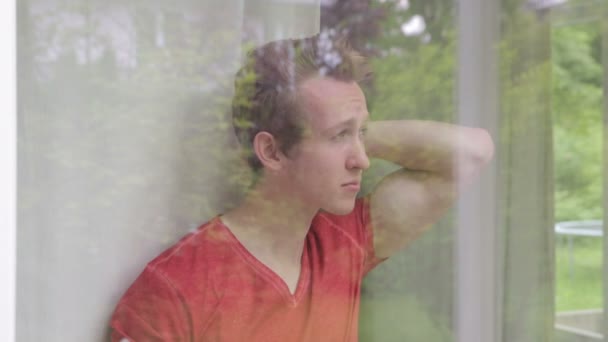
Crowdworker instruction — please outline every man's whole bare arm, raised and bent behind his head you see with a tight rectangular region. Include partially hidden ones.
[365,120,494,257]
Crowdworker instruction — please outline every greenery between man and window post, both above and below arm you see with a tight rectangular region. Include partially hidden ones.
[360,0,456,341]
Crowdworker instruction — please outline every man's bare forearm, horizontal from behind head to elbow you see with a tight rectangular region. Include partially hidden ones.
[365,120,494,177]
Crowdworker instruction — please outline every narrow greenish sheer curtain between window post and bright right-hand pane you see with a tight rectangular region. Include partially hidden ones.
[496,1,555,342]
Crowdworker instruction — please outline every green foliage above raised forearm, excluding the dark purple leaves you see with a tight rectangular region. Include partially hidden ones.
[368,1,456,121]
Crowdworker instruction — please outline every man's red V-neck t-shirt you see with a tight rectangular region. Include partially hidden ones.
[111,199,382,342]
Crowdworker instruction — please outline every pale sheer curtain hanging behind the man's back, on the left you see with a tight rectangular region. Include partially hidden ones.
[17,0,319,341]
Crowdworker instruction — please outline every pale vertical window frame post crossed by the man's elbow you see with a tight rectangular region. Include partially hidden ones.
[454,0,503,342]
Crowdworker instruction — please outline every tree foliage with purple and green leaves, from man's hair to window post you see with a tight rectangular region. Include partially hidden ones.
[322,0,455,121]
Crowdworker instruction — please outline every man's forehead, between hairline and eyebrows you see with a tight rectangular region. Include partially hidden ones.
[298,77,368,129]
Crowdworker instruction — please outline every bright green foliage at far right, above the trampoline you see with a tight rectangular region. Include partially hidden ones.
[552,23,603,221]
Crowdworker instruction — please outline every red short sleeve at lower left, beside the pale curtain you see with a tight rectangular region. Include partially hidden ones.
[110,266,191,342]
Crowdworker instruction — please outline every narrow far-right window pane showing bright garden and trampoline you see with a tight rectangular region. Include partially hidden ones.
[552,1,605,341]
